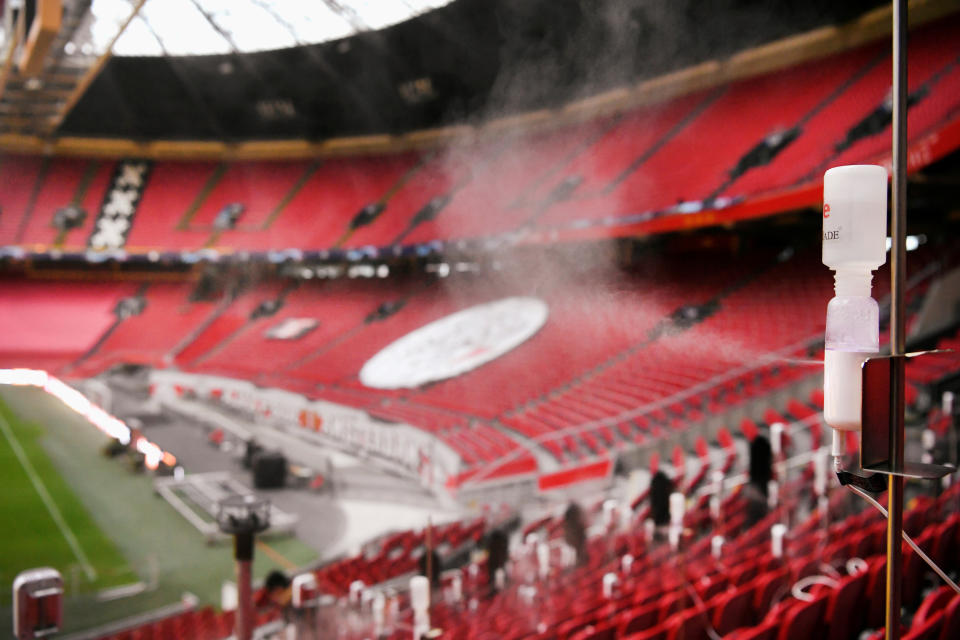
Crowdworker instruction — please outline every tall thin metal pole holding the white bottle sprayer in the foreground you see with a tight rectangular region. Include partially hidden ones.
[886,0,907,640]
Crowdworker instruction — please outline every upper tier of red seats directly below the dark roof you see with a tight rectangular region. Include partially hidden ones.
[0,16,960,253]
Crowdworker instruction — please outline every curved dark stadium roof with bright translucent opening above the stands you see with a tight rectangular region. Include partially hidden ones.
[0,0,882,142]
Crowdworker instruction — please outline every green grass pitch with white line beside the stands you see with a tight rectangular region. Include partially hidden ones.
[0,387,318,633]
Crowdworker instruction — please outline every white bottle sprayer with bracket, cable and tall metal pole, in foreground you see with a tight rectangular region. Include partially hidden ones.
[823,0,960,640]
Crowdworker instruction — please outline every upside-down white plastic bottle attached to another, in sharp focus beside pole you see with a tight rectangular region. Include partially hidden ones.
[823,165,887,444]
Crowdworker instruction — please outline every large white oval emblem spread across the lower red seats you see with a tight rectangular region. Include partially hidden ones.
[360,298,548,389]
